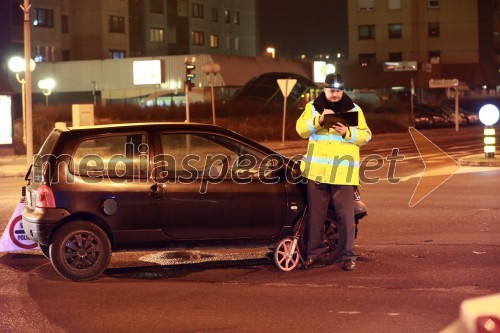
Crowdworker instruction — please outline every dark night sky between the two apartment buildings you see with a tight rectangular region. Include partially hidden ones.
[257,0,347,57]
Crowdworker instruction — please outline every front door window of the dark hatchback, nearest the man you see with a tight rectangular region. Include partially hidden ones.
[155,133,272,179]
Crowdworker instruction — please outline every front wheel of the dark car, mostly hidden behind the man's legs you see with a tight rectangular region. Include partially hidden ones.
[299,210,346,265]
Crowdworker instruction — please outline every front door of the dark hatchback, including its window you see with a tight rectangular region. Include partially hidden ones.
[155,132,286,239]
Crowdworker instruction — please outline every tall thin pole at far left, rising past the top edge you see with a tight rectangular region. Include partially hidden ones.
[21,0,33,166]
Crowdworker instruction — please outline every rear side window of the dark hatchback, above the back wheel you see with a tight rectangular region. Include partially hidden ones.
[69,134,148,179]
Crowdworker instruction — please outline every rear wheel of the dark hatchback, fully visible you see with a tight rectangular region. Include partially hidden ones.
[50,221,111,281]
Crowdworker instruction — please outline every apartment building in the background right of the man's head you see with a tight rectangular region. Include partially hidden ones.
[347,0,500,89]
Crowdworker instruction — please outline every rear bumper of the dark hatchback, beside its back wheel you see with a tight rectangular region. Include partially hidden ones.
[23,206,70,245]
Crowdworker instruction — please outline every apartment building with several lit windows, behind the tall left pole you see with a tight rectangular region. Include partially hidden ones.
[0,0,257,62]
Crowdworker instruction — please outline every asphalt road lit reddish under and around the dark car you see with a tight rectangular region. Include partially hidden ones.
[0,125,500,332]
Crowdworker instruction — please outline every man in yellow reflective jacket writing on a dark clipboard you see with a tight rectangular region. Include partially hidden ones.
[296,74,372,271]
